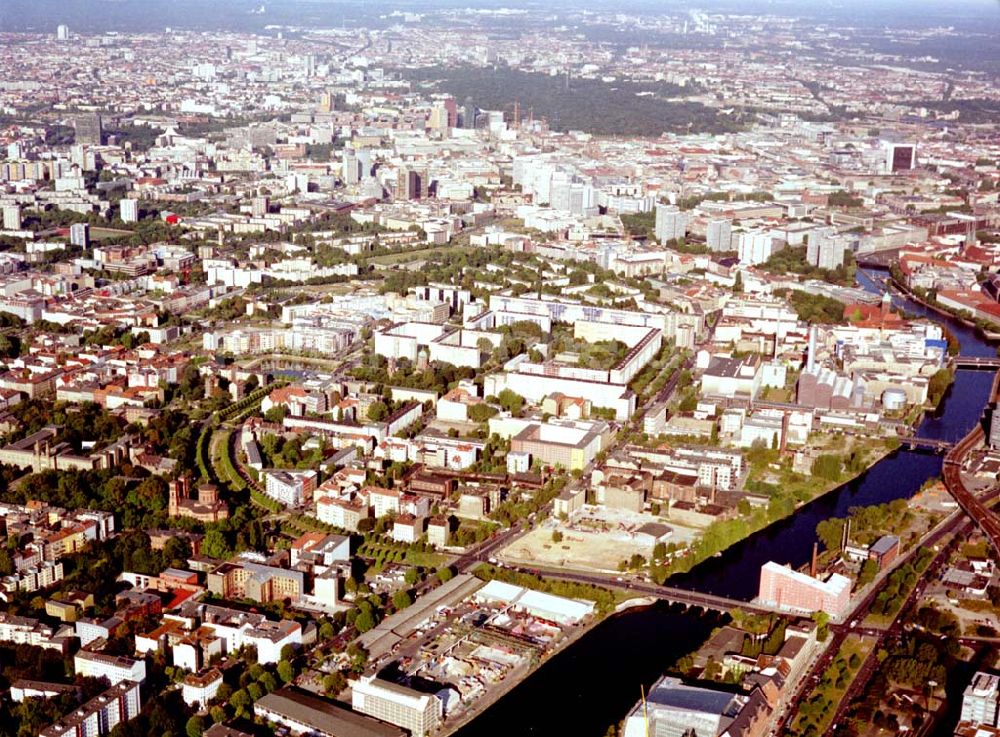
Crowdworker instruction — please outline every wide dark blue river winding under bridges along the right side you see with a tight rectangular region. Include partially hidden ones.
[458,271,996,737]
